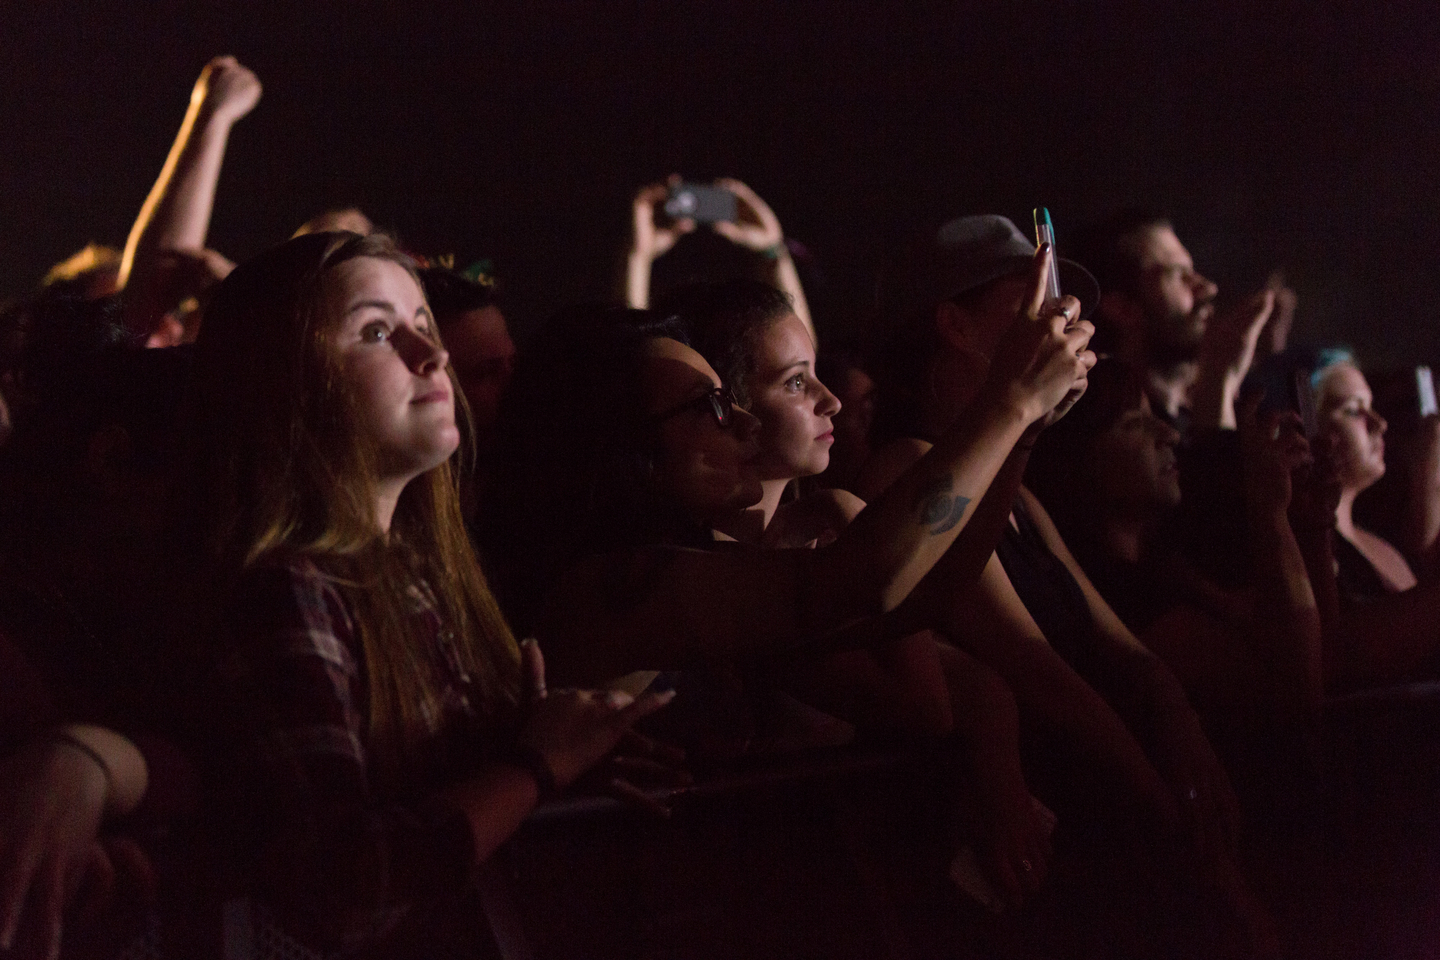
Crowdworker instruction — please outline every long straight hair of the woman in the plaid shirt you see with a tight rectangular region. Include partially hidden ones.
[180,233,520,771]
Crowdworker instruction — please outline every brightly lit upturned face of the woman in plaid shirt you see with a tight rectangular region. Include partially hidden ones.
[324,256,459,481]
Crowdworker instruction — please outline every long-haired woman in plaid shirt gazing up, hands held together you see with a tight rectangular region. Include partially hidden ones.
[177,233,668,956]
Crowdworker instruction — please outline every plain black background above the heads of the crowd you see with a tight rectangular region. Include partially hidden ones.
[0,0,1440,361]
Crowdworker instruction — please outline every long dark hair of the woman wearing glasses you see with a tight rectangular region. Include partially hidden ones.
[477,305,690,632]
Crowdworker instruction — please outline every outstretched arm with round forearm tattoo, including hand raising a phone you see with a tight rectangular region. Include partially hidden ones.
[537,250,1094,682]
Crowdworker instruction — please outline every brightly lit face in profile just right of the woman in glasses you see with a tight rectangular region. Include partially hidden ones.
[747,314,840,481]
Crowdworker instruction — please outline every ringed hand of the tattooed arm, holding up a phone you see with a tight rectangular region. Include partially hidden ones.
[986,245,1096,423]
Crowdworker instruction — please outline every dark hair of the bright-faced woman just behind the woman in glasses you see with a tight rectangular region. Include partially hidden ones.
[655,281,795,407]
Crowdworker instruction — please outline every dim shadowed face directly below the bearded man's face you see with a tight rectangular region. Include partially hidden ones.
[1089,396,1179,514]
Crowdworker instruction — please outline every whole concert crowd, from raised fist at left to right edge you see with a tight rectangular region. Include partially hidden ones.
[0,58,1440,957]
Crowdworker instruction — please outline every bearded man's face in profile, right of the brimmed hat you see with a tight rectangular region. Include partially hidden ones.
[1138,226,1220,356]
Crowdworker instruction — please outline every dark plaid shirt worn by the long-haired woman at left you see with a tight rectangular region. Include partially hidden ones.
[213,561,488,956]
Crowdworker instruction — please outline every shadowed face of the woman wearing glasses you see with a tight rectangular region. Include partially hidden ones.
[639,337,762,522]
